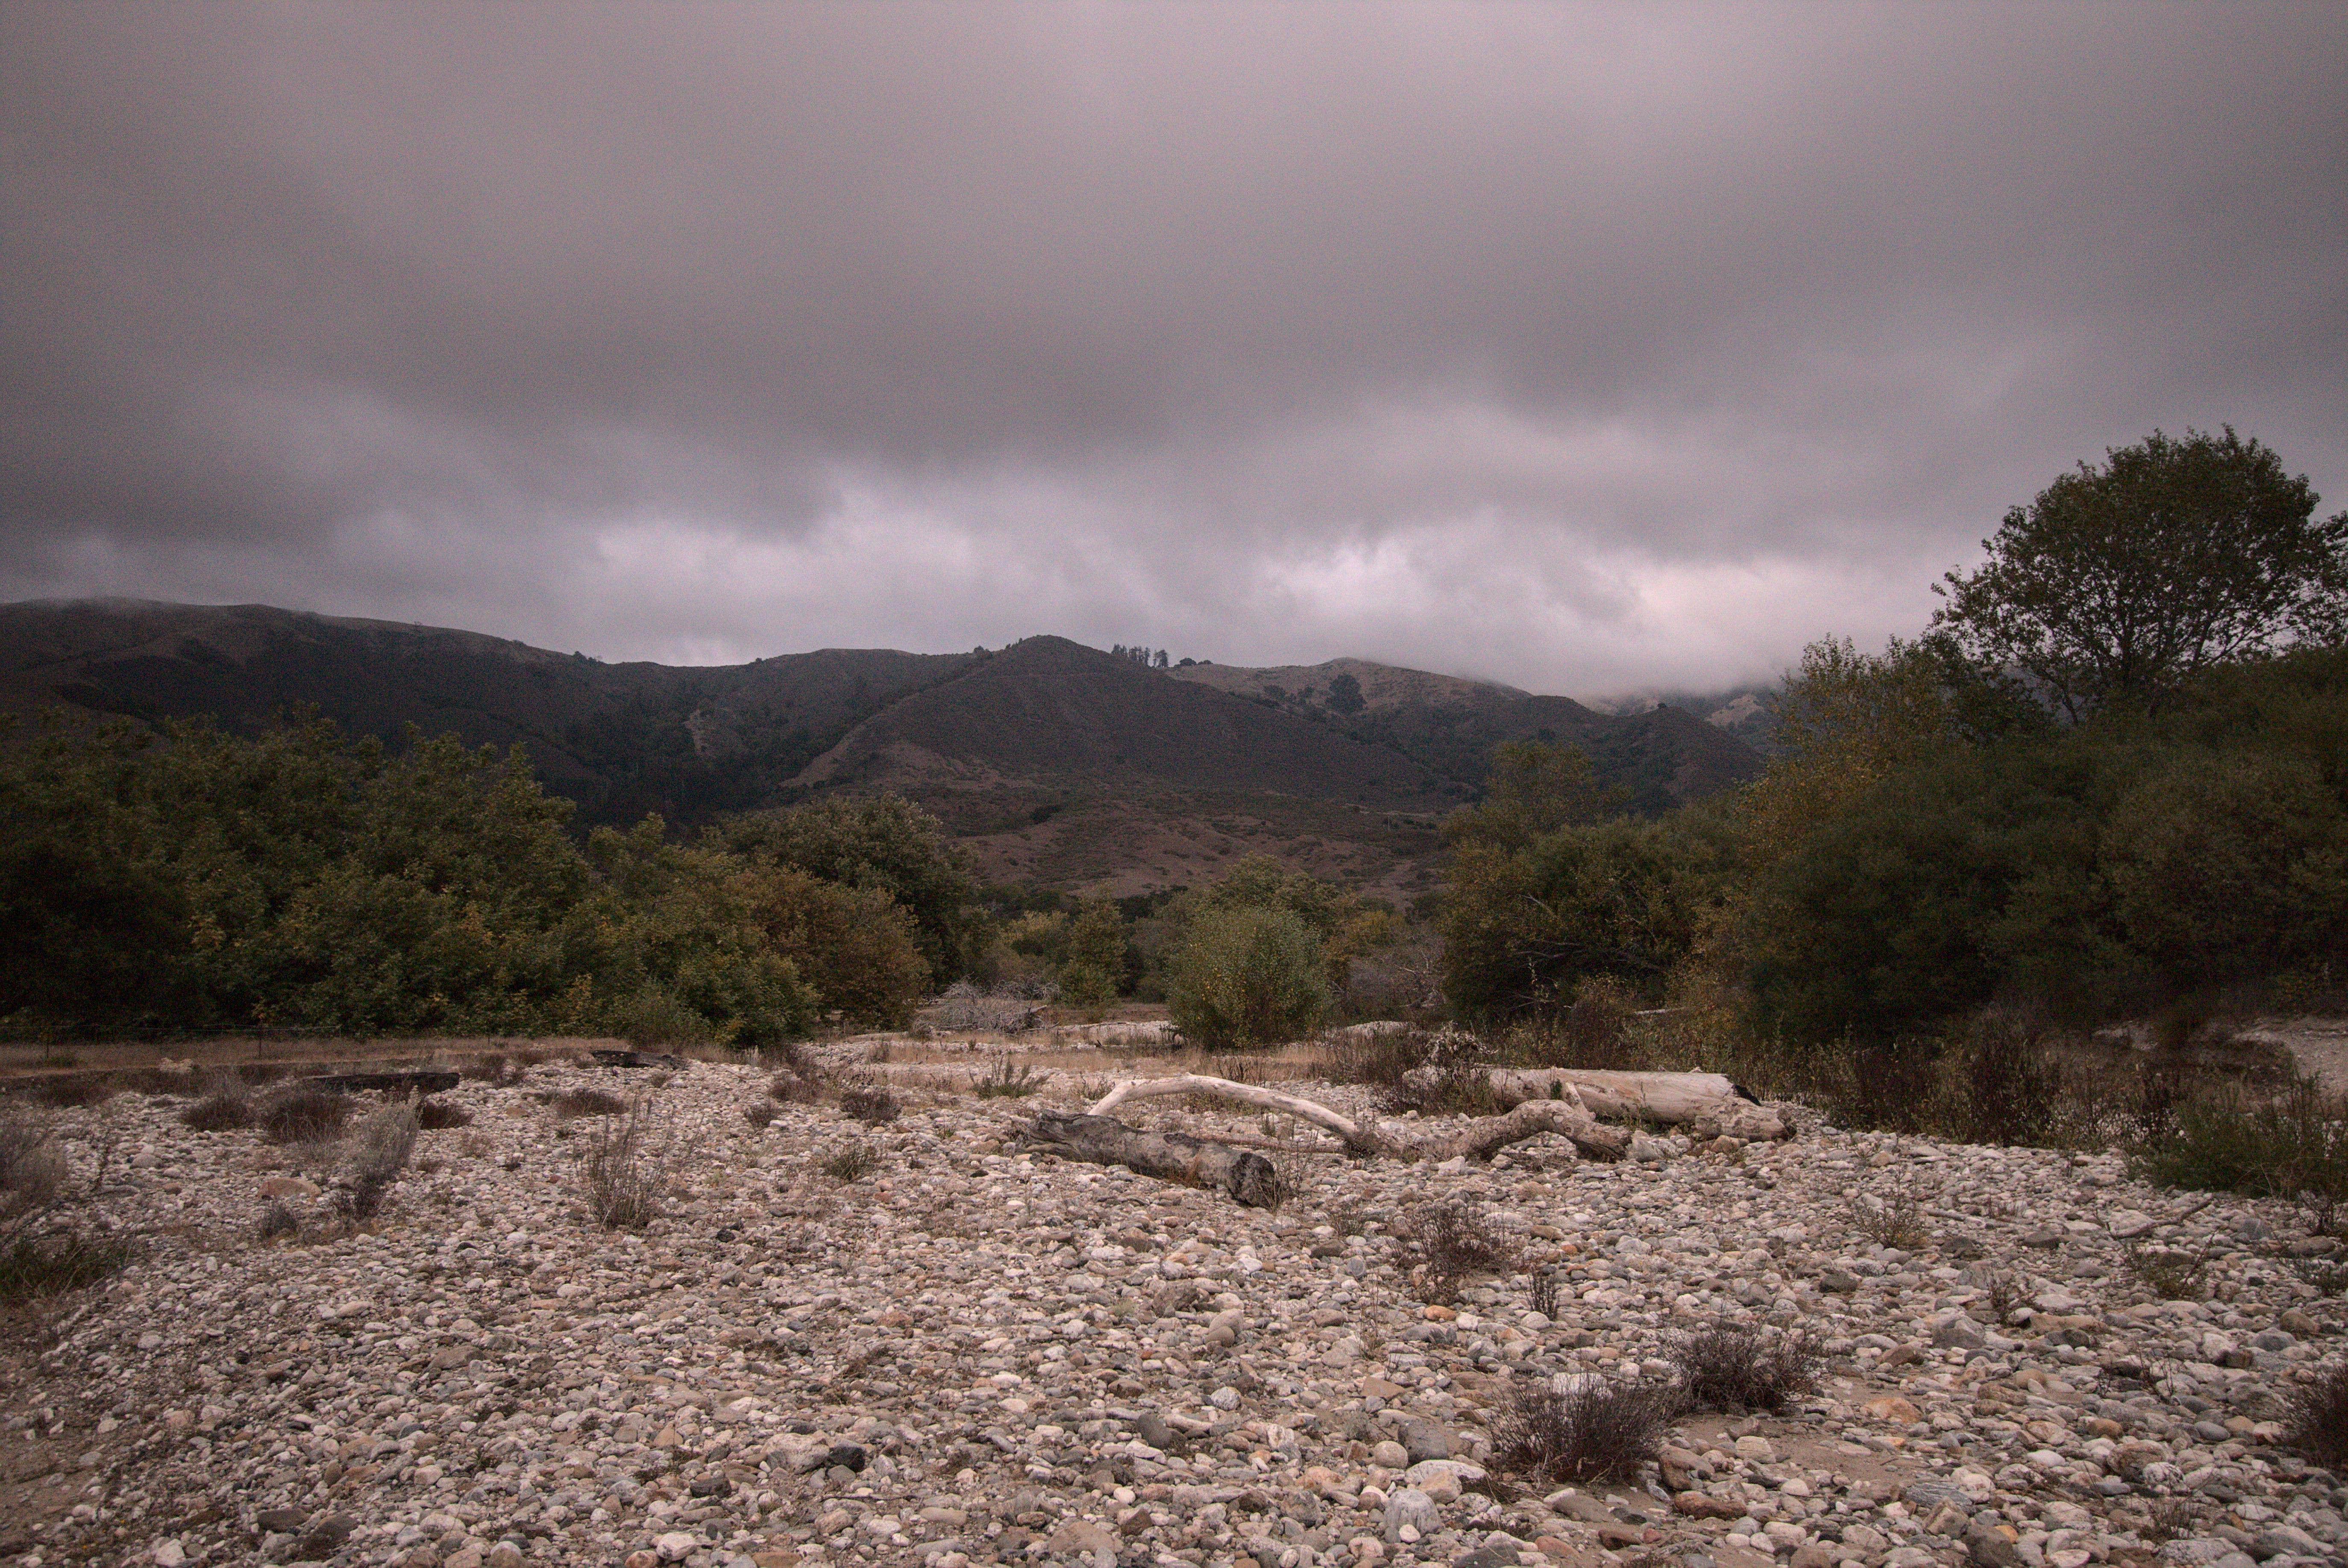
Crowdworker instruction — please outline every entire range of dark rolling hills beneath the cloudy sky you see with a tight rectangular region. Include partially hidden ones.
[0,599,1756,894]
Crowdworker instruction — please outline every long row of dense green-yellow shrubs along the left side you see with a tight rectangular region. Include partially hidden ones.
[0,723,984,1045]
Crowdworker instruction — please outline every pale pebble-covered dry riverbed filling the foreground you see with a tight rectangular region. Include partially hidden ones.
[0,1047,2348,1568]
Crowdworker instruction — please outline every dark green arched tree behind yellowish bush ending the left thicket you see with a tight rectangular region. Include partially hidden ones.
[719,796,989,986]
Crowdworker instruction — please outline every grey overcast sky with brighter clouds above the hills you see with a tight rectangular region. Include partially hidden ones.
[0,0,2348,695]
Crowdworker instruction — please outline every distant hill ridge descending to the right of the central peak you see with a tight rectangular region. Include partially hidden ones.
[1169,660,1761,812]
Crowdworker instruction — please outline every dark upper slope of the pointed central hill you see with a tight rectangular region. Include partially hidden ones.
[801,636,1444,810]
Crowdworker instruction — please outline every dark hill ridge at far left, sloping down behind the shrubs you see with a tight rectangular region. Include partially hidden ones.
[0,599,970,822]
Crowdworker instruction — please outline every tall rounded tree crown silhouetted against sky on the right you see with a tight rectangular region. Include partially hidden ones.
[1932,427,2348,718]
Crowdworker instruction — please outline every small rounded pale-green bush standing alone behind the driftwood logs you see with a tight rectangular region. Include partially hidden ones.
[1167,906,1329,1049]
